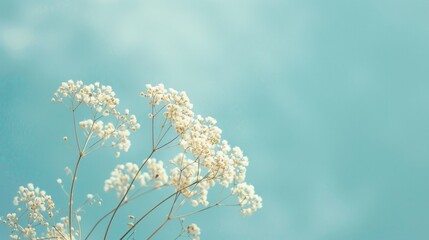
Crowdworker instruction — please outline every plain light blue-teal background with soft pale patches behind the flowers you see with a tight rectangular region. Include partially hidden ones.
[0,0,429,240]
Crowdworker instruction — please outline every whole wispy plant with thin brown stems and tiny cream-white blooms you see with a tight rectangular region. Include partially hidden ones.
[2,80,262,240]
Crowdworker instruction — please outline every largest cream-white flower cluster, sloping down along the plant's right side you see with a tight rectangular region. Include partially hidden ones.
[141,84,262,215]
